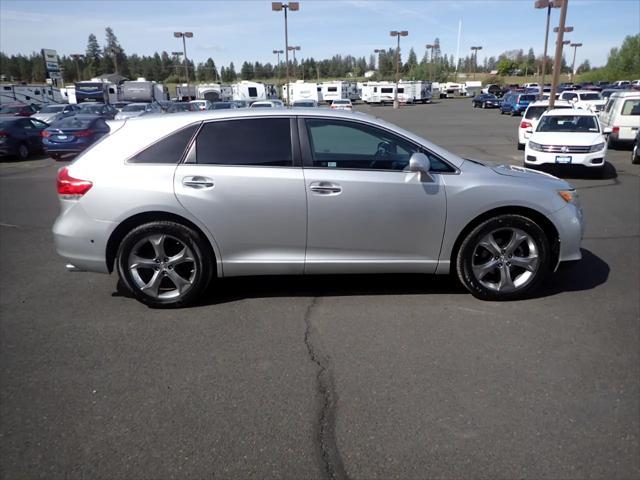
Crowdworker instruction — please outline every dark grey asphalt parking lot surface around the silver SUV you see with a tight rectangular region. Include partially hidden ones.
[0,100,640,479]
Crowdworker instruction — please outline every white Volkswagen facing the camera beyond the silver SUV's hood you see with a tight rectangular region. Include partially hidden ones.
[524,109,610,169]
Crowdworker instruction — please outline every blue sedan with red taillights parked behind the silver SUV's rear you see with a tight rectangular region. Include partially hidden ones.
[42,114,110,160]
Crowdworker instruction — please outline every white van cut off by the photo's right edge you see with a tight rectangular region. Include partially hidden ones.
[600,91,640,147]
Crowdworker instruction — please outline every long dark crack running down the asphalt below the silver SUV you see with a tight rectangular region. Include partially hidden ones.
[304,297,349,480]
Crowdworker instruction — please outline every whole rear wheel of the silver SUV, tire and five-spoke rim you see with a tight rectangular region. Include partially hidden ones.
[116,221,214,308]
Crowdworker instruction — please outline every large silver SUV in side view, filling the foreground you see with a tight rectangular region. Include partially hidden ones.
[53,109,582,307]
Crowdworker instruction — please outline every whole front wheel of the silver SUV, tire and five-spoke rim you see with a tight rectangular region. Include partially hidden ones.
[456,214,549,300]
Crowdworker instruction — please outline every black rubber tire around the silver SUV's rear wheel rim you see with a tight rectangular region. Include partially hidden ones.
[116,221,215,308]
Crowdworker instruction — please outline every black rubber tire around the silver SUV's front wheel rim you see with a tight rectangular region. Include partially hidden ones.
[456,214,550,301]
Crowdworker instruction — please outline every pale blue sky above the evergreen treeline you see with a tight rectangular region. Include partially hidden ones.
[0,0,640,67]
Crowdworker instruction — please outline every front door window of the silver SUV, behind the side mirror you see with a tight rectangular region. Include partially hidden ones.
[306,119,453,172]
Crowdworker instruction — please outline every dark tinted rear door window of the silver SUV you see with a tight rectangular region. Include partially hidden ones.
[196,118,293,167]
